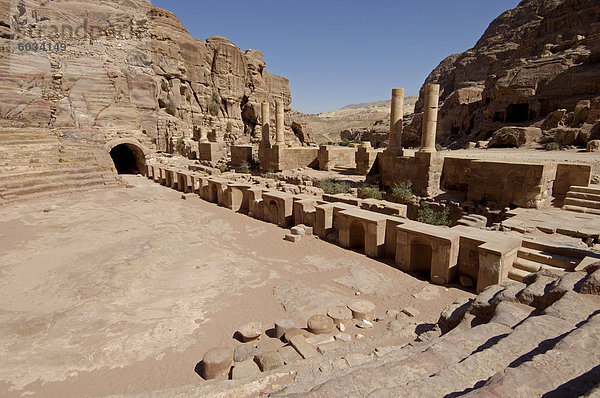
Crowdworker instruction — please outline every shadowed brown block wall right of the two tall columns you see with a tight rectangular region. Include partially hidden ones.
[441,157,557,208]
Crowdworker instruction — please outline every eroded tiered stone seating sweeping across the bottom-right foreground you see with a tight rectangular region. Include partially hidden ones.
[123,263,600,398]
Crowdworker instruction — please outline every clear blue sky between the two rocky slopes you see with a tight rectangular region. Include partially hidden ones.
[152,0,519,113]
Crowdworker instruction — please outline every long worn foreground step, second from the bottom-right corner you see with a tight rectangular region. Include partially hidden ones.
[370,293,597,397]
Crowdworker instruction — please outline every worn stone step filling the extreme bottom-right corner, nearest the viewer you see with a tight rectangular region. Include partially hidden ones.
[466,315,600,398]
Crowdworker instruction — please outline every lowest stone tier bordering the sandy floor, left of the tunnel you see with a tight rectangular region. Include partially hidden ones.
[0,177,118,203]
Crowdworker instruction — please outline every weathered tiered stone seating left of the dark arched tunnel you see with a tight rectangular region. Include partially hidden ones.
[0,128,119,203]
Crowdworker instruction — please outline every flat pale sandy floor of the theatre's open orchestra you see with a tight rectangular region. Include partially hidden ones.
[0,176,470,397]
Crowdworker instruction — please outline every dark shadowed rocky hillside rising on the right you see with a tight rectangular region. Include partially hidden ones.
[414,0,600,145]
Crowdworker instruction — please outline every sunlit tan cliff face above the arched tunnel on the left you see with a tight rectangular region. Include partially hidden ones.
[0,0,294,150]
